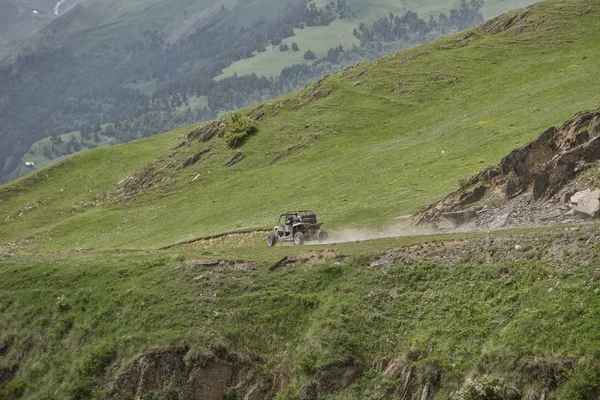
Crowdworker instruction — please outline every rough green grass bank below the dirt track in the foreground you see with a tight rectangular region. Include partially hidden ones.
[0,223,600,399]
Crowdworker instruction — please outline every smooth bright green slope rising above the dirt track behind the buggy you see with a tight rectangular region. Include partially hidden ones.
[0,0,600,252]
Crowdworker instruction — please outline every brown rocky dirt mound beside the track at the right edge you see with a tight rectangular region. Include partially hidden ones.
[415,110,600,230]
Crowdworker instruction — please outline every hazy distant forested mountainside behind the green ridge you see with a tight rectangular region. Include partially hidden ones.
[0,0,532,182]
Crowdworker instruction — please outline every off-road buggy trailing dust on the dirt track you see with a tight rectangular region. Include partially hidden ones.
[267,210,329,246]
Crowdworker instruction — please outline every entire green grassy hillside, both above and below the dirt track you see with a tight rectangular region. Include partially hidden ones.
[0,0,600,400]
